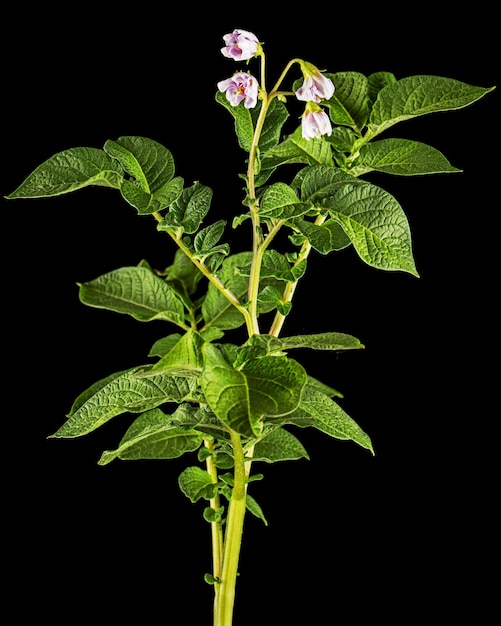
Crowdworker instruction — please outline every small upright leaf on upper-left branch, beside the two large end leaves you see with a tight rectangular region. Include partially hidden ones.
[158,181,212,234]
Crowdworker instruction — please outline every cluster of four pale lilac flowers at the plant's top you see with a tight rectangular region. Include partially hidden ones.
[217,29,334,140]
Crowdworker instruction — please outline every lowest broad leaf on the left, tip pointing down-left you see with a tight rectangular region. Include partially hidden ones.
[98,405,203,465]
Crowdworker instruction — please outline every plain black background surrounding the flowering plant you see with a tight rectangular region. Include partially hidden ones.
[0,3,499,626]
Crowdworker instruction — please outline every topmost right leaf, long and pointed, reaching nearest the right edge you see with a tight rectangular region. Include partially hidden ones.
[369,75,494,136]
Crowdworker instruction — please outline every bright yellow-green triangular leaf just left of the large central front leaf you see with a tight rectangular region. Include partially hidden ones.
[140,329,204,377]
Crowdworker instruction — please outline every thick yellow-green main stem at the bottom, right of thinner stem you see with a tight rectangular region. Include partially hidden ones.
[215,431,247,626]
